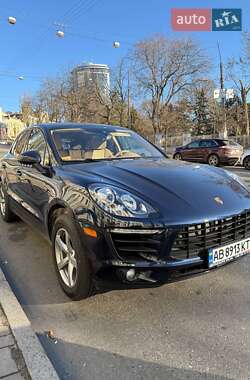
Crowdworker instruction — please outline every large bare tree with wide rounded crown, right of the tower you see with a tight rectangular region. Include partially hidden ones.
[131,36,209,140]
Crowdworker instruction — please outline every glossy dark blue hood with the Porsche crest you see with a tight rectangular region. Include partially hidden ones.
[63,159,250,224]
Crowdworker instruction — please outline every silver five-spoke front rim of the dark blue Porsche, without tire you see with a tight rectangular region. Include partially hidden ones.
[55,228,78,288]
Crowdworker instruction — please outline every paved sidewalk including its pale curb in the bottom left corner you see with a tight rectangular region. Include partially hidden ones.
[0,268,59,380]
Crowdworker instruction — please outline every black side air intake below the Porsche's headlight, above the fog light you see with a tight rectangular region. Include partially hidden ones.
[111,230,165,261]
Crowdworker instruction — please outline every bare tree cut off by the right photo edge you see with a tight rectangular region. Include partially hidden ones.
[228,33,250,136]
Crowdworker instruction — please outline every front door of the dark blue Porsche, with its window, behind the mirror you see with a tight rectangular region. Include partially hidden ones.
[14,128,55,226]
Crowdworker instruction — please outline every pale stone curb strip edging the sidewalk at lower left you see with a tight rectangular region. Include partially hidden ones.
[0,268,60,380]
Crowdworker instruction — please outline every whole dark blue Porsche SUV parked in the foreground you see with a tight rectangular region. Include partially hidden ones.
[0,124,250,299]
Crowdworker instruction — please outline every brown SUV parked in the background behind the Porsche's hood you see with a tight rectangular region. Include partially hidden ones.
[173,139,243,166]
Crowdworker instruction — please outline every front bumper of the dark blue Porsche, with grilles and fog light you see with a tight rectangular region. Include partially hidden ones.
[81,211,250,284]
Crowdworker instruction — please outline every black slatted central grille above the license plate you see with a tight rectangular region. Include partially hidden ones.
[171,211,250,259]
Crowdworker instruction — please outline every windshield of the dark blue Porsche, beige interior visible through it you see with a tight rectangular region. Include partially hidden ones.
[51,127,164,161]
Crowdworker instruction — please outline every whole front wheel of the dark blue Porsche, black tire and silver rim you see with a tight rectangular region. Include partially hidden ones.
[52,214,94,300]
